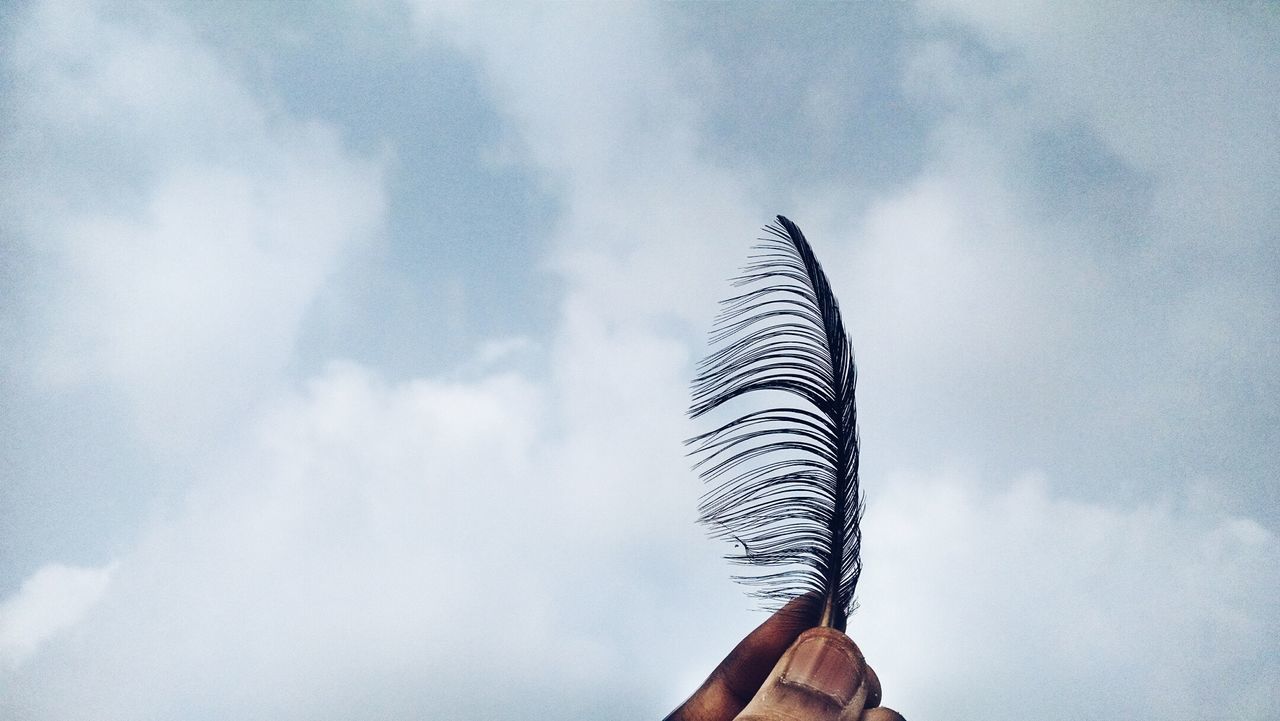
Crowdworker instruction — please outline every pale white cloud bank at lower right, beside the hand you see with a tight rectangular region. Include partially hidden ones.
[851,470,1280,720]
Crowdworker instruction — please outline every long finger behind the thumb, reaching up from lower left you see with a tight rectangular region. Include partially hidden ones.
[664,595,818,721]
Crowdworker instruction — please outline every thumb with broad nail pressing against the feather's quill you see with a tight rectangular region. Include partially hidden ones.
[736,628,868,721]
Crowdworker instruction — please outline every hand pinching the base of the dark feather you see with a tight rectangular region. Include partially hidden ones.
[664,597,904,721]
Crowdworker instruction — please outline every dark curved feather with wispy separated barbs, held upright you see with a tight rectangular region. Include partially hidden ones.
[686,215,863,630]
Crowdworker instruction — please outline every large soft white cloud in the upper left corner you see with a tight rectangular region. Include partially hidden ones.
[4,3,385,447]
